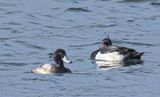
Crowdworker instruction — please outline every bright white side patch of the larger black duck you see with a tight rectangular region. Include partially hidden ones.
[95,52,124,61]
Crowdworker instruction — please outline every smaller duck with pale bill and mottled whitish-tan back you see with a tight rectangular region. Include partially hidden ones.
[32,48,72,74]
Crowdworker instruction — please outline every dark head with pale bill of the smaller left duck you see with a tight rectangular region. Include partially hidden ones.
[52,49,72,63]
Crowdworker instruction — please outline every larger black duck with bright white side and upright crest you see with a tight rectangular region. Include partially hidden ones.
[90,36,144,62]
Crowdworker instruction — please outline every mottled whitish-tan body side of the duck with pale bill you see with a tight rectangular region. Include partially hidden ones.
[32,64,52,74]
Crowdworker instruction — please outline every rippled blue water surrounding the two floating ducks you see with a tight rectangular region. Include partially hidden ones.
[0,0,160,97]
